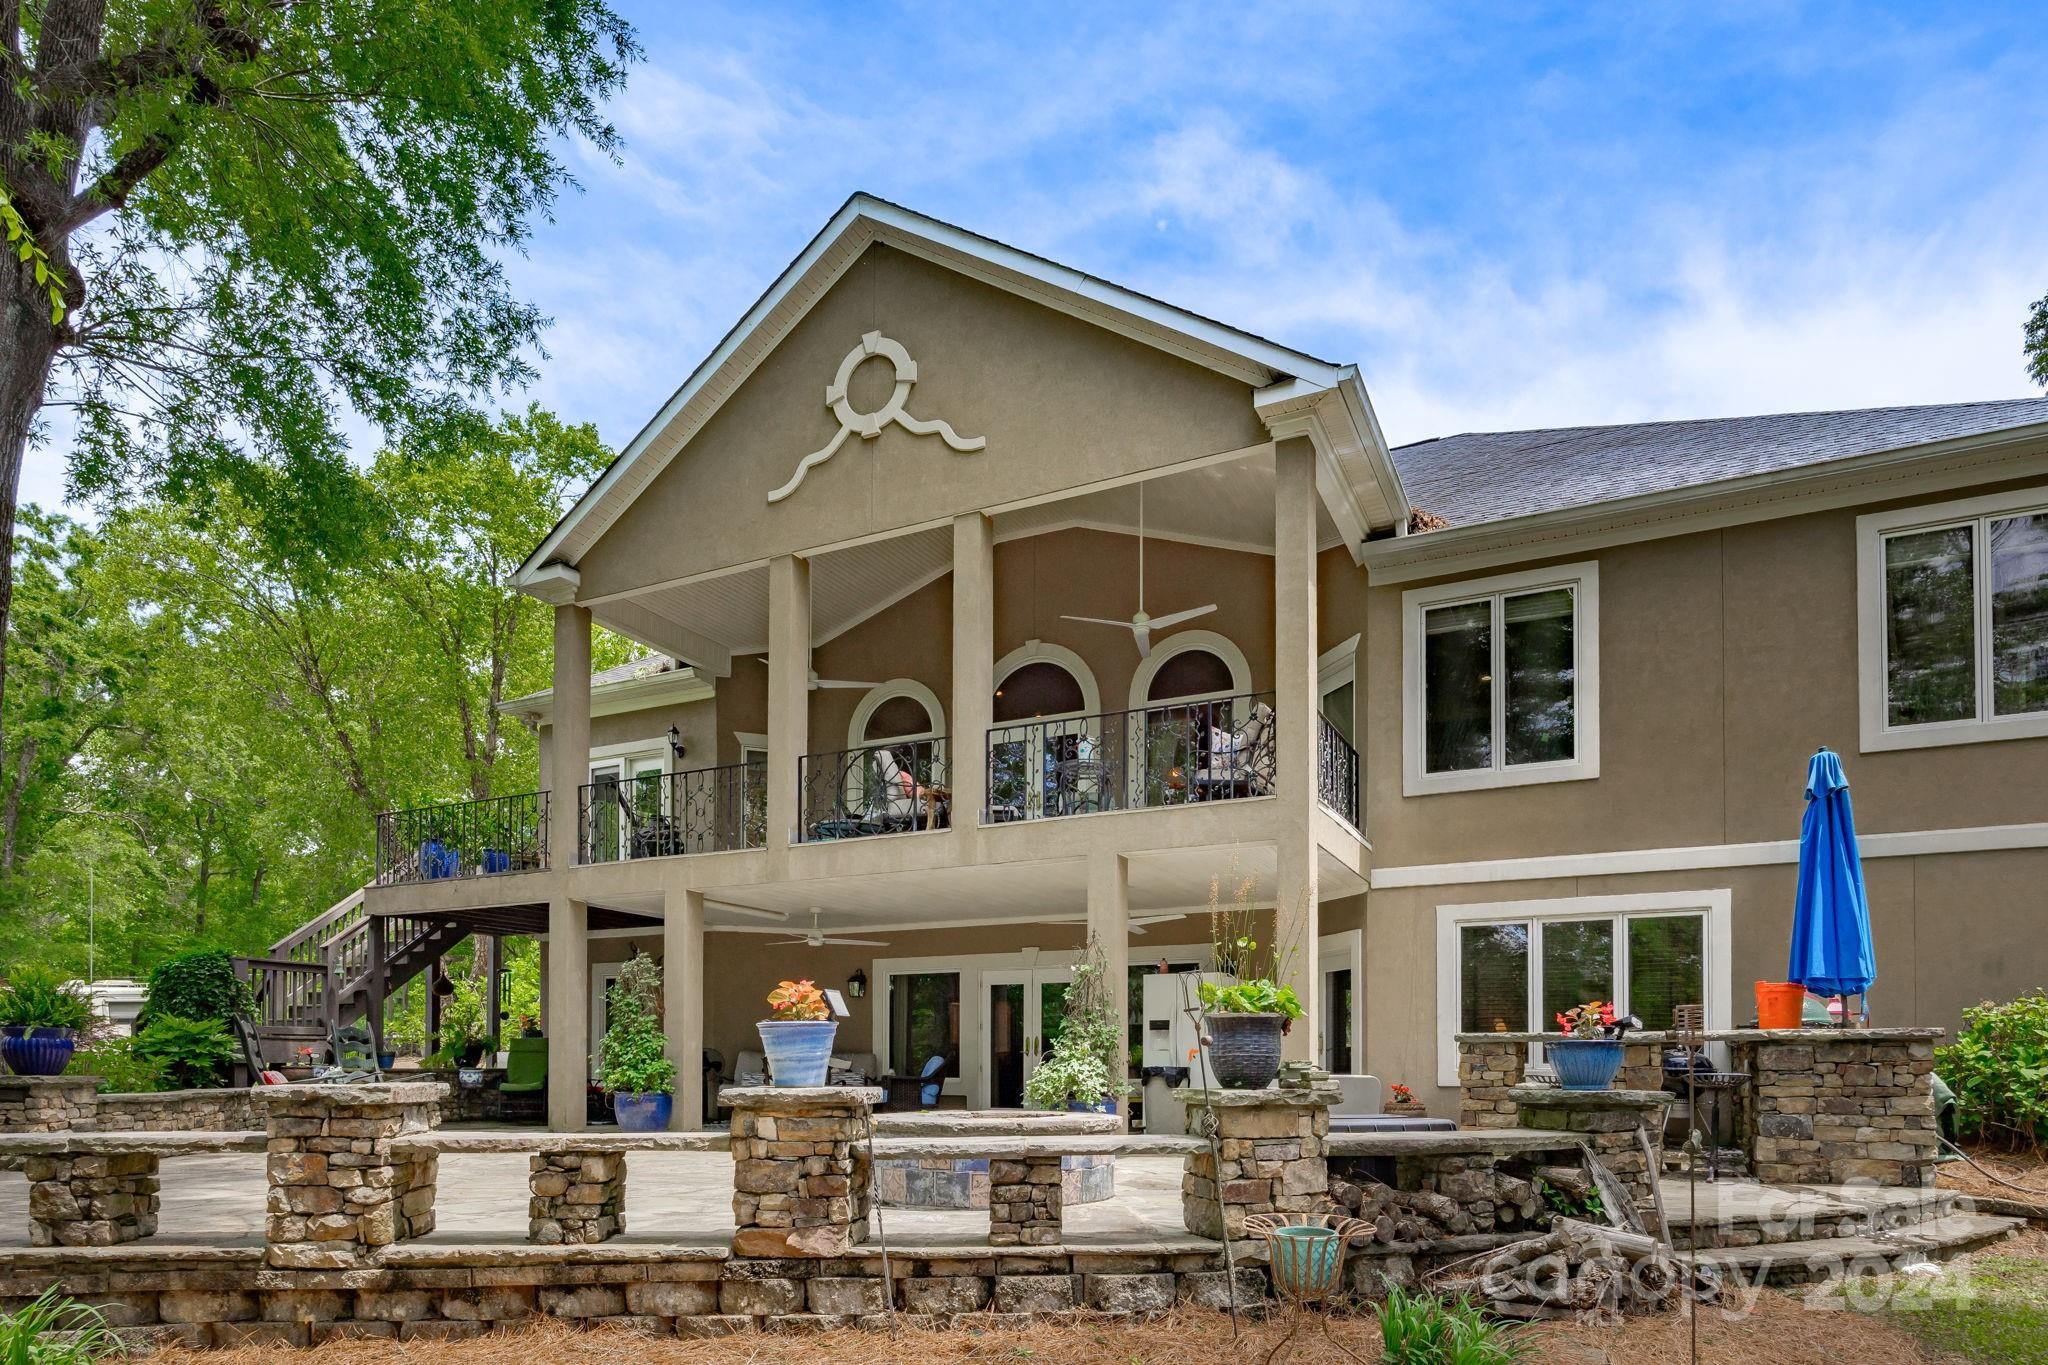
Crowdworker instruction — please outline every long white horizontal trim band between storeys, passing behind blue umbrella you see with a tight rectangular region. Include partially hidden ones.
[1372,821,2048,890]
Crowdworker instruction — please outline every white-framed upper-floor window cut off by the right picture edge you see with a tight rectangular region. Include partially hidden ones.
[1855,489,2048,751]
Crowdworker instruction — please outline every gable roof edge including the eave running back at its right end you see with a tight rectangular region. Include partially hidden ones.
[514,194,1407,591]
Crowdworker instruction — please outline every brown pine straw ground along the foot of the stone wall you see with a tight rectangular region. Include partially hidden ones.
[154,1291,1948,1365]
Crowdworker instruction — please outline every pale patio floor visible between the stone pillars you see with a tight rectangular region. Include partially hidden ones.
[0,1152,1208,1248]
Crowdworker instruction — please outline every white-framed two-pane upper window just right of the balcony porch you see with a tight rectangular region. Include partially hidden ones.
[1401,561,1599,796]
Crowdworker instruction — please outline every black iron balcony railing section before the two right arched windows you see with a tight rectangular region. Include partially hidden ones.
[985,692,1274,825]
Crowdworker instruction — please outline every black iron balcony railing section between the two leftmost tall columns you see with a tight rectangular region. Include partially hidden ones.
[575,763,768,864]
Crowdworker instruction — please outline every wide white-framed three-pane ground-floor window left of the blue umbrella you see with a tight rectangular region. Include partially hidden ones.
[1436,888,1733,1085]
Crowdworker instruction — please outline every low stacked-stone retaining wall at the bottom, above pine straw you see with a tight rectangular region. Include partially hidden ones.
[0,1244,1266,1347]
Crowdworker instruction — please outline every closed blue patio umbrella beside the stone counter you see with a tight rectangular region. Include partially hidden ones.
[1786,749,1878,1002]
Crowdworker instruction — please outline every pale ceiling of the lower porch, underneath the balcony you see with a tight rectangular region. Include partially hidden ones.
[592,843,1364,937]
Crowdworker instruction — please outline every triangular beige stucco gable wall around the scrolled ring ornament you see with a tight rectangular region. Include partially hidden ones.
[578,244,1266,596]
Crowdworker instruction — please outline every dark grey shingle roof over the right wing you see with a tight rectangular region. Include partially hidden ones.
[1393,399,2048,526]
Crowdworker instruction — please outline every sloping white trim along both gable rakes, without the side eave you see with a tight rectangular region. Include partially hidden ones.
[514,194,1391,587]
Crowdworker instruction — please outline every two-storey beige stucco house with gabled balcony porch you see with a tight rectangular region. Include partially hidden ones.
[352,196,2048,1128]
